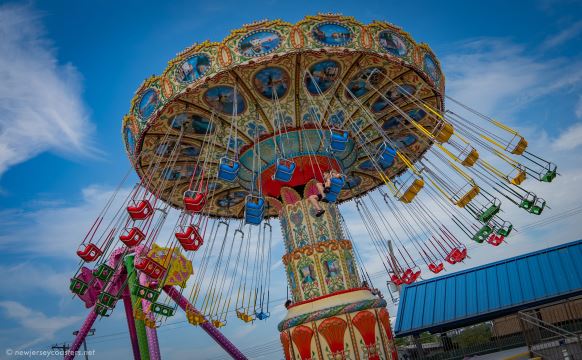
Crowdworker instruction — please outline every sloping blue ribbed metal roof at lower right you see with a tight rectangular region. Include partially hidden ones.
[394,240,582,336]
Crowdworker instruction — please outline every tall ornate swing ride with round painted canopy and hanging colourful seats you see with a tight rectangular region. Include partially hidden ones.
[66,14,557,360]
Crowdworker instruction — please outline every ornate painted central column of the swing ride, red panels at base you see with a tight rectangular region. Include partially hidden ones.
[279,180,397,360]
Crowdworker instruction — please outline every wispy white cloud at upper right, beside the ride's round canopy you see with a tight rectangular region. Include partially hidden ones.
[442,39,582,119]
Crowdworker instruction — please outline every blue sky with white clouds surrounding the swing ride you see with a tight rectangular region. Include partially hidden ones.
[0,0,582,359]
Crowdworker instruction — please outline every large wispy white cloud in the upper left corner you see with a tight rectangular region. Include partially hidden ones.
[0,5,93,175]
